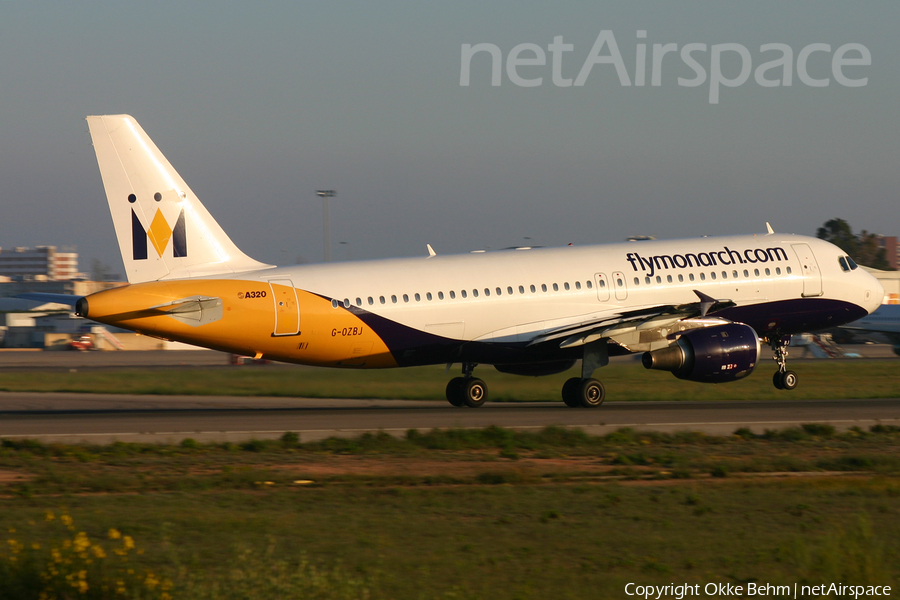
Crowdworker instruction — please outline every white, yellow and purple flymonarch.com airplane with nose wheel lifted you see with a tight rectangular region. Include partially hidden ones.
[22,115,883,408]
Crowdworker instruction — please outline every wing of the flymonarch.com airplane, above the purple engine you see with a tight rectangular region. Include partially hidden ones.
[528,290,735,348]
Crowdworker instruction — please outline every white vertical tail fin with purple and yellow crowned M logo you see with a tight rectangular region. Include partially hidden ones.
[87,115,271,283]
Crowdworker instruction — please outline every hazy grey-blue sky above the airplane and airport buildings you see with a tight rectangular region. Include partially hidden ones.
[0,0,900,272]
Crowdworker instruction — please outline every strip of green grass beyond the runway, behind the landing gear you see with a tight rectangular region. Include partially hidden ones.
[0,360,900,401]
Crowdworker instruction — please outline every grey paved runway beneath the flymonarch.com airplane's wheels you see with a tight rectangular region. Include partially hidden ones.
[0,393,900,444]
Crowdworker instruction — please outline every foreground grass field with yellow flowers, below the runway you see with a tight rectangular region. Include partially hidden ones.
[0,424,900,600]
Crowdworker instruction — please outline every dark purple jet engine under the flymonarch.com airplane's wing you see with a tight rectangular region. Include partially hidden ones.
[641,323,759,383]
